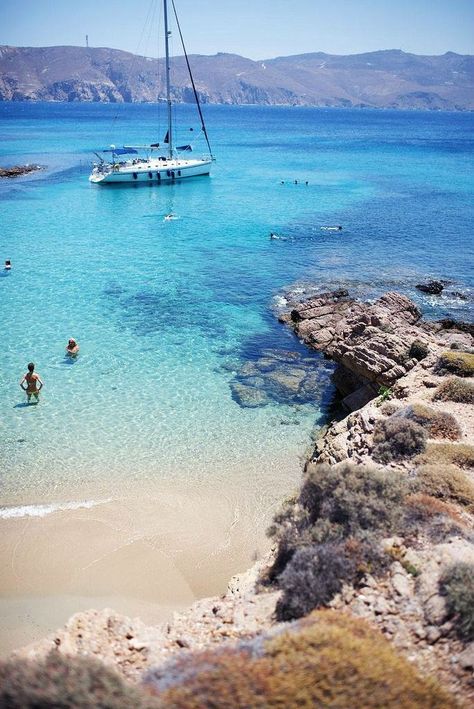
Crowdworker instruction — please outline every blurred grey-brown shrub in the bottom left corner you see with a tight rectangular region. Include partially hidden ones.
[0,651,158,709]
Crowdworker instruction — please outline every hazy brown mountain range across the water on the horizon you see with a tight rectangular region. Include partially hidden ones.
[0,46,474,111]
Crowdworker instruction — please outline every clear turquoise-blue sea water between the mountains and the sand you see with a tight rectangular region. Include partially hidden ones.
[0,104,474,508]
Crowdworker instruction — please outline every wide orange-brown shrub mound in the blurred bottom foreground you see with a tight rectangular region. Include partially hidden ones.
[145,612,457,709]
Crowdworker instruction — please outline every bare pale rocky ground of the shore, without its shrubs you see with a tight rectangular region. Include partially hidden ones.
[8,286,474,703]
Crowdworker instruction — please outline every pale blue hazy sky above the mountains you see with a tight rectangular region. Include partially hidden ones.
[0,0,474,59]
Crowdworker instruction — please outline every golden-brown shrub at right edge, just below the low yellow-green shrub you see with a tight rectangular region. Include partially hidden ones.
[417,464,474,512]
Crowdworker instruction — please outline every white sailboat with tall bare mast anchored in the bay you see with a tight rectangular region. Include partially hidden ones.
[89,0,214,185]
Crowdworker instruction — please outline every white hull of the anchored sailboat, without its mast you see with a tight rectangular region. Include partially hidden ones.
[89,158,212,185]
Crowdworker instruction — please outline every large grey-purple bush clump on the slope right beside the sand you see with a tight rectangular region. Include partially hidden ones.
[269,463,408,619]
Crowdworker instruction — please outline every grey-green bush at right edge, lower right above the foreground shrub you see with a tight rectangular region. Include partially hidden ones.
[440,563,474,641]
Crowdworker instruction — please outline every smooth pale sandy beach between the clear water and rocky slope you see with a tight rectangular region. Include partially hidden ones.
[0,468,299,656]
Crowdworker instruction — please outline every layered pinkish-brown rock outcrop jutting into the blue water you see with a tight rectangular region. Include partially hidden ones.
[280,290,470,410]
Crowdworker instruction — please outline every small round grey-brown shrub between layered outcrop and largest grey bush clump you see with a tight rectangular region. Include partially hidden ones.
[373,414,426,463]
